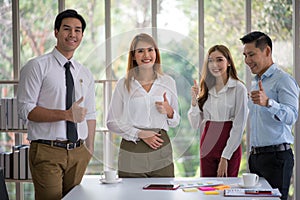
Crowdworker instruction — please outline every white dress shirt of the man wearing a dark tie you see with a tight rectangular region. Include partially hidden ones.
[17,48,96,140]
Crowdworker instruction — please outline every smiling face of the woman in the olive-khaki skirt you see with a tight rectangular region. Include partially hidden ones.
[134,41,156,68]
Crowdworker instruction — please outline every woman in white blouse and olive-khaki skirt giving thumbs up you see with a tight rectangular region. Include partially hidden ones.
[106,33,180,177]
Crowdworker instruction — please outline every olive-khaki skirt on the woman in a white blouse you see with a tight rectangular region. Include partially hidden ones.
[118,129,174,178]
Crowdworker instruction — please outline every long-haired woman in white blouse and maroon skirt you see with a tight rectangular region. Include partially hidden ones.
[188,45,248,177]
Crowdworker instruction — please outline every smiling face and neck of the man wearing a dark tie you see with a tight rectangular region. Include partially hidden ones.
[55,18,83,59]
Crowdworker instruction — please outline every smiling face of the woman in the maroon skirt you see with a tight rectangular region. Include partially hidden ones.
[208,51,230,80]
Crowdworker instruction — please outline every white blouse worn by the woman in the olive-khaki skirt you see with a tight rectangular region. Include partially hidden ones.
[106,75,180,142]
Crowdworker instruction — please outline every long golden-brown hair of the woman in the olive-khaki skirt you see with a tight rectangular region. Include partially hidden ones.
[125,33,163,91]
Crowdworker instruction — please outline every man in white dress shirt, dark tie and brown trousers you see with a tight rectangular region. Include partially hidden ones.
[17,10,96,200]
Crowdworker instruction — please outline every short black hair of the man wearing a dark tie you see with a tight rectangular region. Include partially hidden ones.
[54,9,86,32]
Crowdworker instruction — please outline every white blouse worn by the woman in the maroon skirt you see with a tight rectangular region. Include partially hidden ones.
[188,78,248,159]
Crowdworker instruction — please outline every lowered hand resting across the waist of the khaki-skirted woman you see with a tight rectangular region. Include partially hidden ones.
[138,130,164,149]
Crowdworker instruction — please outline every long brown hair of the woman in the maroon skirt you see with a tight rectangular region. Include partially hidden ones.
[198,45,240,111]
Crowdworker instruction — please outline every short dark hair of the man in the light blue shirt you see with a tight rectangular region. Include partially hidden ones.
[240,31,272,50]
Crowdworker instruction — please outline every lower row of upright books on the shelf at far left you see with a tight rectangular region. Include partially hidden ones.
[0,145,32,180]
